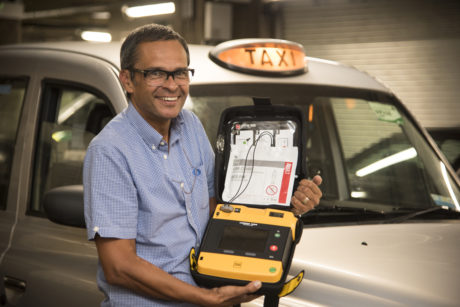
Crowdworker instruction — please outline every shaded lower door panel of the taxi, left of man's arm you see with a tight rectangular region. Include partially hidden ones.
[2,216,103,306]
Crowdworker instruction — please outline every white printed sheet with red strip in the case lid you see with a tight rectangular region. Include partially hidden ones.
[222,142,298,206]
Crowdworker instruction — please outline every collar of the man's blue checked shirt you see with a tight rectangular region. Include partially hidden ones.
[126,101,184,148]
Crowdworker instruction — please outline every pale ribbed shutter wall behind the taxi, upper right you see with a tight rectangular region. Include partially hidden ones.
[279,0,460,127]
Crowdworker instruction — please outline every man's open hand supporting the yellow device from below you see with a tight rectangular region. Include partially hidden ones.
[204,281,262,307]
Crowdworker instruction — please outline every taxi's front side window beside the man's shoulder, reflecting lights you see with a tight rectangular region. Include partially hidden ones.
[29,84,113,215]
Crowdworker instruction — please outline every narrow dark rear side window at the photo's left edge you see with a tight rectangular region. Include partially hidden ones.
[0,77,27,209]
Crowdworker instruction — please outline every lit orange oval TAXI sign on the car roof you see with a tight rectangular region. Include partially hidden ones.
[209,38,307,76]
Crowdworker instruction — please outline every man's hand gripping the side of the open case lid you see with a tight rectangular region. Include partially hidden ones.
[291,175,323,215]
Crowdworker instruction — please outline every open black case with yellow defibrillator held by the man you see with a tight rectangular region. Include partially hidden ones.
[190,105,305,306]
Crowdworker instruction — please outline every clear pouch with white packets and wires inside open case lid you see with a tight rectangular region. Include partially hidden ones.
[222,120,298,206]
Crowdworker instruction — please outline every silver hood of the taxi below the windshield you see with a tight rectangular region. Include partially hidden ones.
[280,222,460,306]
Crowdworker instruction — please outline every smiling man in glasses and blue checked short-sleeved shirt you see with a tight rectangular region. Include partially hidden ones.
[83,25,321,307]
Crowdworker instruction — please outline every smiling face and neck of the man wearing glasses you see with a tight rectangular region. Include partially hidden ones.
[120,40,193,142]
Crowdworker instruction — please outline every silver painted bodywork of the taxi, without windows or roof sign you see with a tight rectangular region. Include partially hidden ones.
[0,42,460,306]
